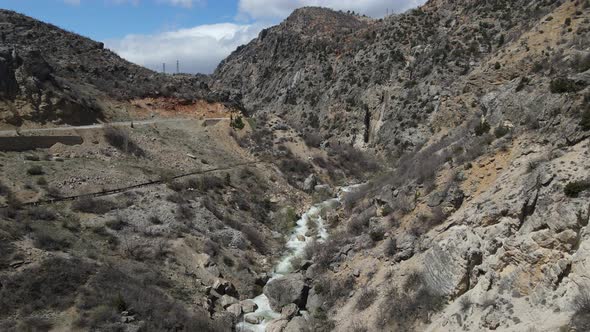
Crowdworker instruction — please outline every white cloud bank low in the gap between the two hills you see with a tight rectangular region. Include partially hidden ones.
[105,23,264,74]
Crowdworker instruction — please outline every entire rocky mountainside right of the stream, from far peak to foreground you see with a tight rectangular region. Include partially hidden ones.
[213,0,590,331]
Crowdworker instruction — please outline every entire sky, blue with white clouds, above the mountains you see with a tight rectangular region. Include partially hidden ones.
[0,0,424,73]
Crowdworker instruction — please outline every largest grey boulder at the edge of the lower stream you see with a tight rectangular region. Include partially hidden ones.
[263,274,309,311]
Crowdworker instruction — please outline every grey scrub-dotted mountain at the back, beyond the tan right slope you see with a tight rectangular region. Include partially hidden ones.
[213,0,584,152]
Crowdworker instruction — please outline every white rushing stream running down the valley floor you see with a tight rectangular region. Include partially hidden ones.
[237,185,359,332]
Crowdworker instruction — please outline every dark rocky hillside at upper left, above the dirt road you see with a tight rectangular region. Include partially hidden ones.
[0,10,214,125]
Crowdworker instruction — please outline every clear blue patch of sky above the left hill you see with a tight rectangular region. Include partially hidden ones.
[0,0,245,40]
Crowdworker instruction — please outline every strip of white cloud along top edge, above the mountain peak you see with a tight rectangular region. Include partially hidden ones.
[238,0,425,19]
